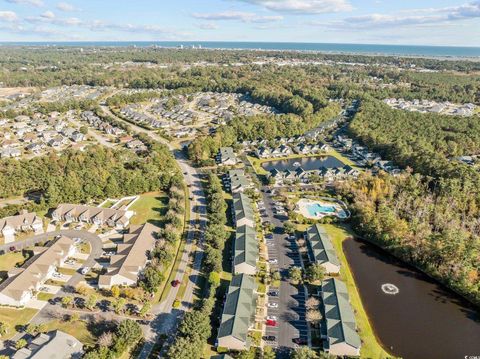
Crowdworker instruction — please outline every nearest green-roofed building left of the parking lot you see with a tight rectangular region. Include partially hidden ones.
[218,274,257,342]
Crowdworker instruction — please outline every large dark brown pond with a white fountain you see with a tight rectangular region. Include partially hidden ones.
[343,239,480,359]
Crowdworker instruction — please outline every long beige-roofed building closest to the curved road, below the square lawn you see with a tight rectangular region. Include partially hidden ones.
[98,223,158,289]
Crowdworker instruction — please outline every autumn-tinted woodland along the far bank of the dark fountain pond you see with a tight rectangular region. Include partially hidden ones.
[337,173,480,305]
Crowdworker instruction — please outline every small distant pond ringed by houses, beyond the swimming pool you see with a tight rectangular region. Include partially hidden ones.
[262,156,345,172]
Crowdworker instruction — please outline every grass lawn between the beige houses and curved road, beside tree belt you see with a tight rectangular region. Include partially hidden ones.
[129,192,167,224]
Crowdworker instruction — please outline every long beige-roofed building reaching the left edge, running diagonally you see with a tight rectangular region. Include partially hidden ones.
[0,237,76,307]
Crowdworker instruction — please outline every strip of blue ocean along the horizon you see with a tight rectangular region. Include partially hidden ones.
[0,41,480,58]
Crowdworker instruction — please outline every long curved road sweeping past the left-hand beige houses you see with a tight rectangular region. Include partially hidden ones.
[100,105,207,359]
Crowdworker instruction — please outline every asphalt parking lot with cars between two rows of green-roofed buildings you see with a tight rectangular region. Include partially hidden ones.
[262,187,308,358]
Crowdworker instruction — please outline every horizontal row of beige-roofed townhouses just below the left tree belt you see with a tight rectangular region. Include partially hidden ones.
[52,204,133,229]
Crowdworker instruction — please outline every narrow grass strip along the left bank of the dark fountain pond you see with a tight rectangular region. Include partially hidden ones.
[323,224,391,358]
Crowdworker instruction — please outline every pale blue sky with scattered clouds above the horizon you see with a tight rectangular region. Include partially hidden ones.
[0,0,480,46]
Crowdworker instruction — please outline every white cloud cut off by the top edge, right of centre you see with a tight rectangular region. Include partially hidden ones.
[236,0,353,15]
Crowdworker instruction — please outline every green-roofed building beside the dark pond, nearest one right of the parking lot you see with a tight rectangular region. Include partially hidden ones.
[322,278,361,348]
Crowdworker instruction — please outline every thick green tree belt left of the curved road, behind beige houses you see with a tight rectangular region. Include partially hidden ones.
[0,144,182,215]
